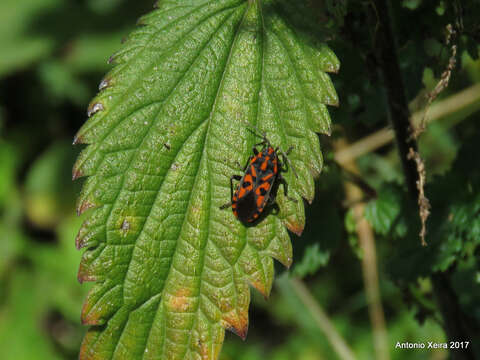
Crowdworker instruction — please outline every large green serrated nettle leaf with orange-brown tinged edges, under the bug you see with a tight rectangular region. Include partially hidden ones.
[73,0,339,359]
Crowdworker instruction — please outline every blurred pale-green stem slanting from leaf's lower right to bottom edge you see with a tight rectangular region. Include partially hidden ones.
[289,278,355,360]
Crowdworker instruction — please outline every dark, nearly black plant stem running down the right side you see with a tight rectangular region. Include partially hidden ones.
[373,0,475,360]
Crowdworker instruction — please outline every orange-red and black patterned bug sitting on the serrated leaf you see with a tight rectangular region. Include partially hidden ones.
[220,128,297,223]
